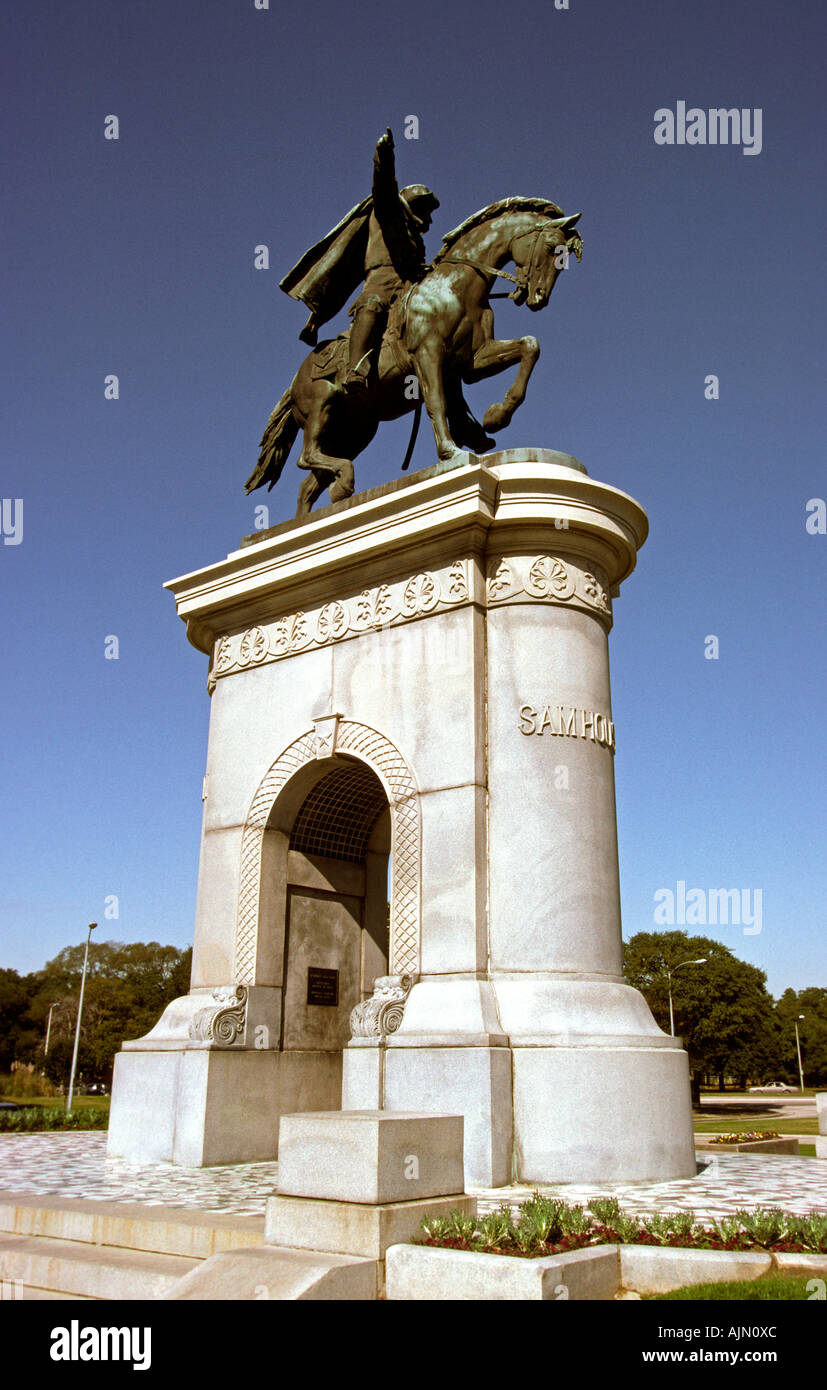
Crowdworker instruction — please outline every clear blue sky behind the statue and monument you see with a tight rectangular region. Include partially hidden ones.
[0,0,827,992]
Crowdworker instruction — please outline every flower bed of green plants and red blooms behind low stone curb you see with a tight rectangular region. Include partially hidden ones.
[416,1193,827,1259]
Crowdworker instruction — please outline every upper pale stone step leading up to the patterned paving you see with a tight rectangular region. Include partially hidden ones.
[0,1191,264,1259]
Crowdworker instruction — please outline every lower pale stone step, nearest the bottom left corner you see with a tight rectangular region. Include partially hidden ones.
[0,1233,200,1300]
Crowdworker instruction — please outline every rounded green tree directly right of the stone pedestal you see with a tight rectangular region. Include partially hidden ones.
[623,931,781,1099]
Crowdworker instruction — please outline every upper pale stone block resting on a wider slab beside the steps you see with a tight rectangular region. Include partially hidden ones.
[278,1111,464,1204]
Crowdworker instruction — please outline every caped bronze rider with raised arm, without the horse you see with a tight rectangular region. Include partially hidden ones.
[281,131,439,393]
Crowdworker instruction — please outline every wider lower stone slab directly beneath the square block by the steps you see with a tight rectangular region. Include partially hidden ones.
[264,1194,477,1259]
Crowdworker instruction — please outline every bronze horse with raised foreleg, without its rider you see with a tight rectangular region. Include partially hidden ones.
[246,197,582,516]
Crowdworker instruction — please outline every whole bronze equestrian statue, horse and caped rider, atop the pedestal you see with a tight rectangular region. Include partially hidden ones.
[246,131,582,516]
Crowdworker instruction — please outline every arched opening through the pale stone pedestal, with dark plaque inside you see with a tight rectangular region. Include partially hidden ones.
[248,752,393,1111]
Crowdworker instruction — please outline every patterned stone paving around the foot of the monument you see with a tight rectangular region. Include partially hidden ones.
[0,1133,827,1219]
